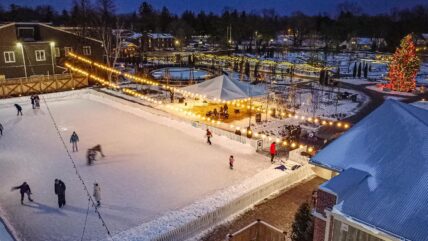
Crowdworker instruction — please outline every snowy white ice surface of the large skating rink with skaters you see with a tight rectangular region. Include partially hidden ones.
[0,91,270,241]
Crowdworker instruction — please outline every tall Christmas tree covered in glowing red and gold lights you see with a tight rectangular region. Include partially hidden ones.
[385,35,420,92]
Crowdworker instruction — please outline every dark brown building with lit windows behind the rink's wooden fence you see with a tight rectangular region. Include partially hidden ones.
[0,23,103,79]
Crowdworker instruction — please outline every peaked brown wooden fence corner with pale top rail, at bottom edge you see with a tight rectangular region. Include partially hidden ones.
[225,219,287,241]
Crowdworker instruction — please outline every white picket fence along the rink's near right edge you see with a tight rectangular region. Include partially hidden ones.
[152,164,315,241]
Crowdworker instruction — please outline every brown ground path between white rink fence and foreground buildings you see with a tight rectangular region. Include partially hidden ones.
[201,177,325,241]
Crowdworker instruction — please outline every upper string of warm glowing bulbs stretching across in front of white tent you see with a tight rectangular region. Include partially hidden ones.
[68,52,350,129]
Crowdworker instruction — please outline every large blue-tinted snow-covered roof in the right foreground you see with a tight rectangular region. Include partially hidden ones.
[311,100,428,240]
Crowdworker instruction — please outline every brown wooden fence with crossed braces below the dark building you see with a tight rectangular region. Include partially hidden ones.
[0,74,88,98]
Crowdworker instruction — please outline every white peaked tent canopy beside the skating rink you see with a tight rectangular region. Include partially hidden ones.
[181,75,266,101]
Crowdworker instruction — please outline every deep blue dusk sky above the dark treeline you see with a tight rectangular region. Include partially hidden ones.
[1,0,427,14]
